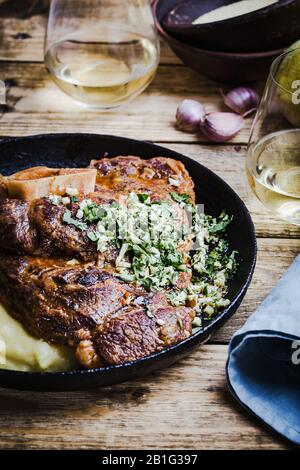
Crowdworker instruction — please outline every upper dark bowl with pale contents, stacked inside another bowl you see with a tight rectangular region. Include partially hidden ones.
[163,0,300,52]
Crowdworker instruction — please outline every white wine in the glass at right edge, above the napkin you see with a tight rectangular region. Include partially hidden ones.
[247,129,300,225]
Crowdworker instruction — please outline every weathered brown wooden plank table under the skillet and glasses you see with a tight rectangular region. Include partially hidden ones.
[0,0,300,449]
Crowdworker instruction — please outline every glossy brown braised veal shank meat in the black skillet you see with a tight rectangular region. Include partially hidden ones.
[0,157,195,368]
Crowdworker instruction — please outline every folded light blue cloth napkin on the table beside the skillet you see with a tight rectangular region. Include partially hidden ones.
[226,255,300,444]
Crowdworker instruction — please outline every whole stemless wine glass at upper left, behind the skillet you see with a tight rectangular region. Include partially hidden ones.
[45,0,159,109]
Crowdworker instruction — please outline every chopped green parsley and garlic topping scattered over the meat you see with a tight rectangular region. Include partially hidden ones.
[58,192,237,324]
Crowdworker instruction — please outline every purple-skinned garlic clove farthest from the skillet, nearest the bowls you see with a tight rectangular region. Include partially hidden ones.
[221,87,259,117]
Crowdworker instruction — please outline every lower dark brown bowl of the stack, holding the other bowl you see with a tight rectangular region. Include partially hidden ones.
[153,0,284,84]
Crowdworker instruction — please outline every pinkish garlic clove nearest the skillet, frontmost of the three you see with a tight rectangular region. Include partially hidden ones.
[200,112,245,142]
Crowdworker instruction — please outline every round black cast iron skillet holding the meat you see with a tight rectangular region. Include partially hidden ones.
[0,134,256,391]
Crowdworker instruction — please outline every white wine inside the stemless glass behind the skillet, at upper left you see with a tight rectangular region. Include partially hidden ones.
[45,33,159,109]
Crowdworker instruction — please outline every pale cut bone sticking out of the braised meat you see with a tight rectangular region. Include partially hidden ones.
[5,167,97,201]
